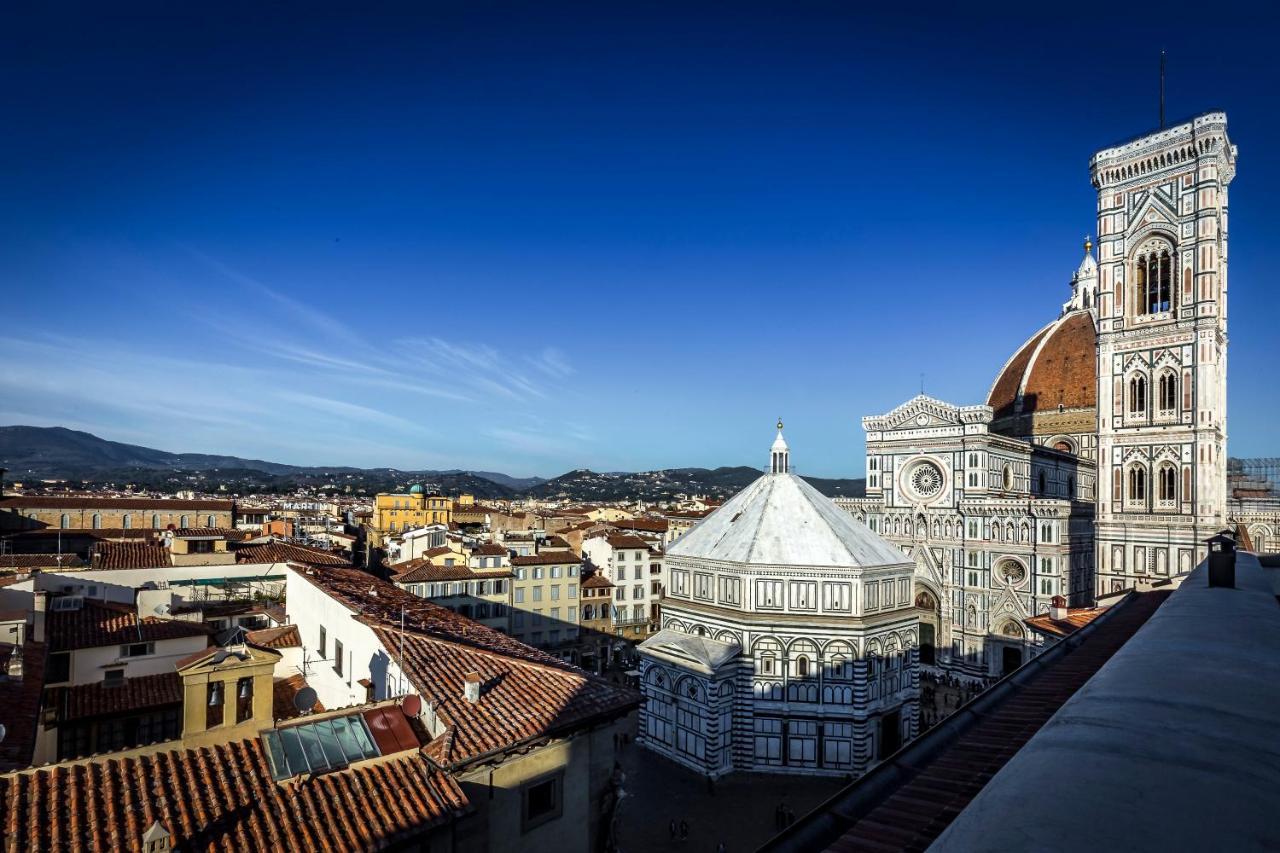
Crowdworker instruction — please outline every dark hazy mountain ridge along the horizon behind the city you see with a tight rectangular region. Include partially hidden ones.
[0,425,863,501]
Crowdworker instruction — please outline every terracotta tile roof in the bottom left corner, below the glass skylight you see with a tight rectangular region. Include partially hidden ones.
[0,722,468,853]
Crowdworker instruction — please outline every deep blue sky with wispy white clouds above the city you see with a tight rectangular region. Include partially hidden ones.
[0,3,1280,476]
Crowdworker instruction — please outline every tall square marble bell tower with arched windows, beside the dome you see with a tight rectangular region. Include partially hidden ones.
[1089,113,1236,594]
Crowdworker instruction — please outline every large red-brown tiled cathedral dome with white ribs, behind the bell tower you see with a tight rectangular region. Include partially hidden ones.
[987,309,1098,435]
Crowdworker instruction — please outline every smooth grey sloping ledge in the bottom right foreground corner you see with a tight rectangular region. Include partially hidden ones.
[929,552,1280,853]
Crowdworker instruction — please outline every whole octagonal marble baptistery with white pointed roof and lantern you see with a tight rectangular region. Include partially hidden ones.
[639,421,919,777]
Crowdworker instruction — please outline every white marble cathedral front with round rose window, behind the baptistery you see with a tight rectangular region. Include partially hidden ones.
[837,394,1096,679]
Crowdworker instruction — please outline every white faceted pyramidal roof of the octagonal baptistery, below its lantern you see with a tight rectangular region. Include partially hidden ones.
[667,473,910,569]
